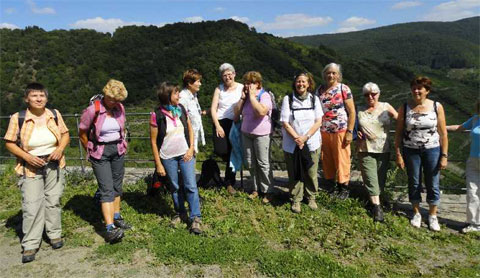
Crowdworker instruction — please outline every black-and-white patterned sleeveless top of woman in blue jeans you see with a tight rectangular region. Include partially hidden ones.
[403,103,440,149]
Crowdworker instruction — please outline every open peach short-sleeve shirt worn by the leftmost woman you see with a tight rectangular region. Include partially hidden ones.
[4,109,68,177]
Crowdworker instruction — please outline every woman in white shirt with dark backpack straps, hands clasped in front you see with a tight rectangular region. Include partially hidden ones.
[280,72,323,213]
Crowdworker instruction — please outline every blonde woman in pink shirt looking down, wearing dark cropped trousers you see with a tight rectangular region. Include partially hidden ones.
[78,79,131,243]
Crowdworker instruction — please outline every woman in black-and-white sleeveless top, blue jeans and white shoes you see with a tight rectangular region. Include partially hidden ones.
[395,76,448,231]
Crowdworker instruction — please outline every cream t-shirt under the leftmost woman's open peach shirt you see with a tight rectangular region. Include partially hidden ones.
[28,125,57,156]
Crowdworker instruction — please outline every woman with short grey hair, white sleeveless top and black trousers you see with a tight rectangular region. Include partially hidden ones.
[210,63,243,194]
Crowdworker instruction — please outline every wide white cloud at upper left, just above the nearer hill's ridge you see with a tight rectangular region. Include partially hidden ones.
[70,17,165,33]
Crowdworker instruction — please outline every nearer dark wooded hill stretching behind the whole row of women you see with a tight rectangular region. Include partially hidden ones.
[0,17,478,124]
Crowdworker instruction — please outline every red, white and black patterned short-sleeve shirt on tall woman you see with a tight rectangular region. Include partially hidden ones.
[317,83,353,133]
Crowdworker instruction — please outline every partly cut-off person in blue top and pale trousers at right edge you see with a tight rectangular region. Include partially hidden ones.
[447,100,480,233]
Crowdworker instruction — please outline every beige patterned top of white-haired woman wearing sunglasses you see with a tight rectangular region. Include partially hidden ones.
[357,102,390,153]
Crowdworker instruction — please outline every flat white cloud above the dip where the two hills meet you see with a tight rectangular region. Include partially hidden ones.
[253,14,333,31]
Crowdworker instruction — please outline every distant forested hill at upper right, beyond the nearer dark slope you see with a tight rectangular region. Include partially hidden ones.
[289,16,480,69]
